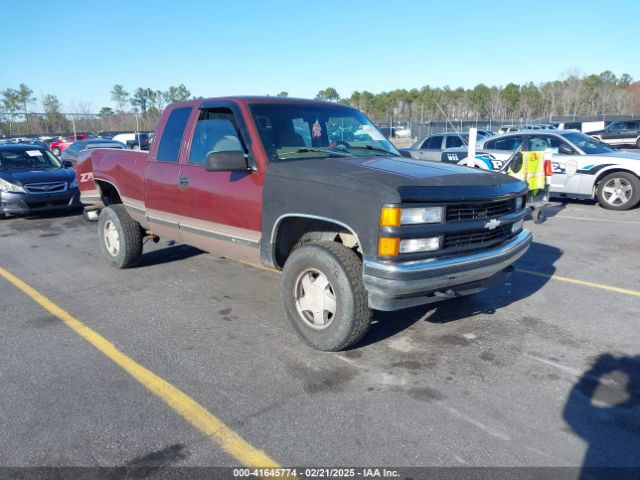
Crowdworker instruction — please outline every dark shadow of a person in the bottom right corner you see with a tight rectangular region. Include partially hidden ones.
[563,353,640,480]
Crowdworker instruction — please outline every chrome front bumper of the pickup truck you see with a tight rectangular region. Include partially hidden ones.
[363,230,532,310]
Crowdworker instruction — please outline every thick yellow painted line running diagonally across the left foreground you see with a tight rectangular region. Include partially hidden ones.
[0,267,279,467]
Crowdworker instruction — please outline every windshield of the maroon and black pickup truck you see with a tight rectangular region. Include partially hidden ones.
[251,103,400,161]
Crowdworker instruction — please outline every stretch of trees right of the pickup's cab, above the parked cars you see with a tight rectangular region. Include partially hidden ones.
[316,70,640,122]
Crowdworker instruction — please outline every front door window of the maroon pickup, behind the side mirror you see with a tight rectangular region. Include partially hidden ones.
[189,108,244,165]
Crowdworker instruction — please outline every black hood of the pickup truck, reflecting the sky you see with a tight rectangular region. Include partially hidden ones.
[267,156,526,203]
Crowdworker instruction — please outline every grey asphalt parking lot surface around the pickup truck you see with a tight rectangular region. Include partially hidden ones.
[0,202,640,466]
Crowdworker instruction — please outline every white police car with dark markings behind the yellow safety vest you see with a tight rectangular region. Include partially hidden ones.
[441,130,640,210]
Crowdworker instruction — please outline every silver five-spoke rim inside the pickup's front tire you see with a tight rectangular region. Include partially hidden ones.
[293,268,336,330]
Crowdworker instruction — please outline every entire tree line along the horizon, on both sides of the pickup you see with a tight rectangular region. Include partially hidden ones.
[0,70,640,134]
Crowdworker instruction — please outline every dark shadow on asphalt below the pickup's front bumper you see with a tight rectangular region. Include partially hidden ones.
[353,242,563,349]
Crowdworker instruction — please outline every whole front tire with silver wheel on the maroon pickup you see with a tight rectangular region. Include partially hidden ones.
[281,242,372,352]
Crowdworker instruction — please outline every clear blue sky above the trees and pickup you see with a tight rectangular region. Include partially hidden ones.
[0,0,640,111]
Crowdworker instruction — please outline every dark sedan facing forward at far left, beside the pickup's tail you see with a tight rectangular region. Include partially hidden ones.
[0,144,80,217]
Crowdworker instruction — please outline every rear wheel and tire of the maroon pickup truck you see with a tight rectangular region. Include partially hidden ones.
[98,205,142,268]
